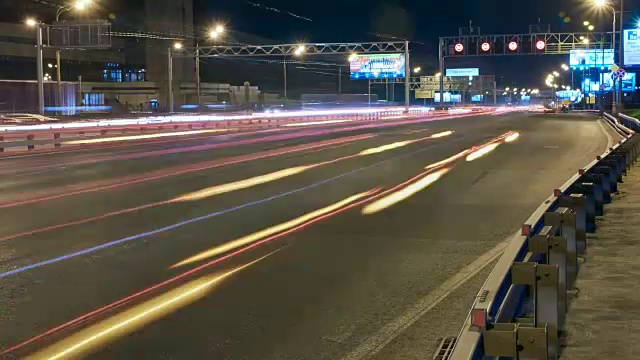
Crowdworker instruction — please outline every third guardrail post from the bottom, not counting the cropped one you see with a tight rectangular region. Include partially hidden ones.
[544,208,578,289]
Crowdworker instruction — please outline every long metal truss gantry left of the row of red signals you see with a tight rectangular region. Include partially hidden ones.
[168,41,411,112]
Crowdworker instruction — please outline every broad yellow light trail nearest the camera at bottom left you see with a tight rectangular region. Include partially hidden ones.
[28,250,277,360]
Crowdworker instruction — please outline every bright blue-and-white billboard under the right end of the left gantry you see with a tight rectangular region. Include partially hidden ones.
[349,54,406,80]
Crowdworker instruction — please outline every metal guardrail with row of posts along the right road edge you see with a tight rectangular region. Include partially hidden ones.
[449,114,640,360]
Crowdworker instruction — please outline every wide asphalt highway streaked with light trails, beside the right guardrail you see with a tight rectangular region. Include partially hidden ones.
[0,113,612,360]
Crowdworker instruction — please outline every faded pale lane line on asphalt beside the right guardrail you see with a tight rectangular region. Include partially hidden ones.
[342,237,511,360]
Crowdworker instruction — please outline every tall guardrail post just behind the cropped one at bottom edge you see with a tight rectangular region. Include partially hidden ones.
[511,262,559,359]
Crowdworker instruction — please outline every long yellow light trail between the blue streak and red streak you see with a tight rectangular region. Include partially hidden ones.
[171,191,371,268]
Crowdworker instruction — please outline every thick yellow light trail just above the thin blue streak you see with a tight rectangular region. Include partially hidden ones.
[171,164,318,202]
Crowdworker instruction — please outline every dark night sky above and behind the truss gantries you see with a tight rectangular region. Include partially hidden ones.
[196,0,640,86]
